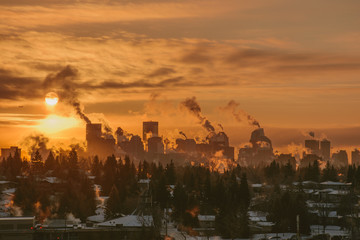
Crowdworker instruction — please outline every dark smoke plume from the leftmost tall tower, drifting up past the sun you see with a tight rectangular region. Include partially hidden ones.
[43,65,91,123]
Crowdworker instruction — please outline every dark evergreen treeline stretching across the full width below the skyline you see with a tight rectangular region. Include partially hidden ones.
[0,149,360,238]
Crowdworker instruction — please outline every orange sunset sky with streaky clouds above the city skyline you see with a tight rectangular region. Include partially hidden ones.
[0,0,360,154]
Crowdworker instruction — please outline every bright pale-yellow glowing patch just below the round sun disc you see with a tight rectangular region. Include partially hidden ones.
[36,115,79,133]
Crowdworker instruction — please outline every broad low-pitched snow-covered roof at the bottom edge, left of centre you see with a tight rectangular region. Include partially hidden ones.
[98,215,153,227]
